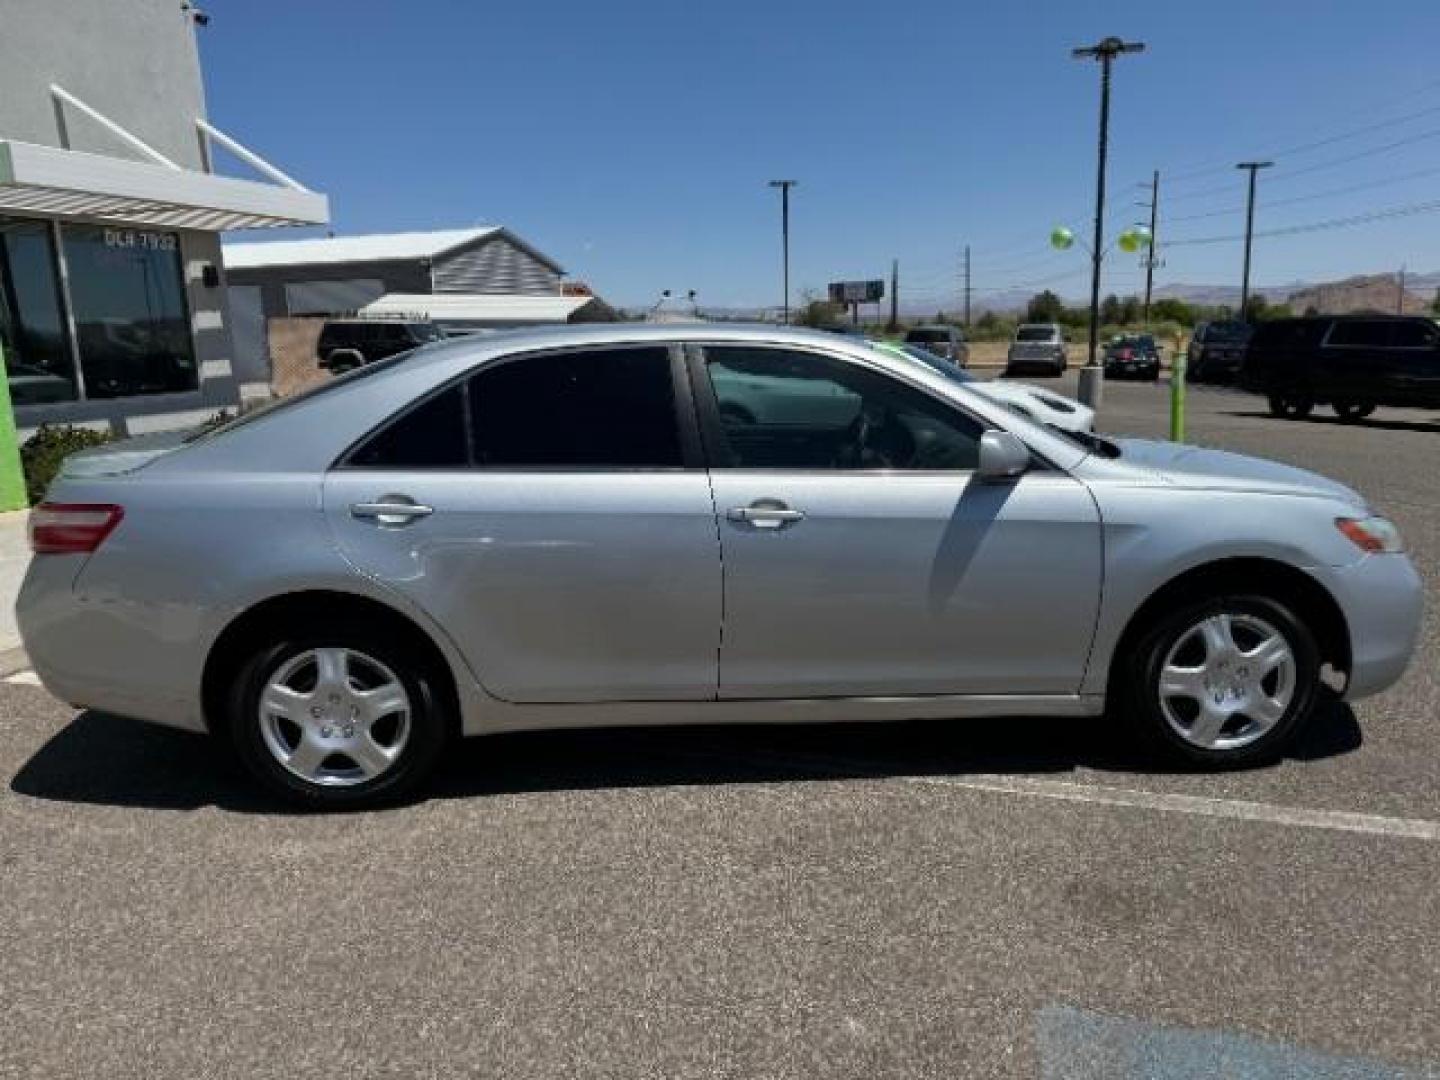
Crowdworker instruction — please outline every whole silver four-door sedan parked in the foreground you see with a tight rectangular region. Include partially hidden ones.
[17,324,1421,806]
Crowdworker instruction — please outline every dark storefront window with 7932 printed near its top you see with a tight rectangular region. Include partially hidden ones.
[60,225,200,397]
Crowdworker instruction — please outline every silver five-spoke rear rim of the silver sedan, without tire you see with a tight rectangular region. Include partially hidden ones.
[259,648,410,788]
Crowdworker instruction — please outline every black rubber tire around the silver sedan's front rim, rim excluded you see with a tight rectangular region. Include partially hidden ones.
[1112,593,1322,770]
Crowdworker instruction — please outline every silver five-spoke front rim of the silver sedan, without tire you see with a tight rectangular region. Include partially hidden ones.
[1156,613,1297,750]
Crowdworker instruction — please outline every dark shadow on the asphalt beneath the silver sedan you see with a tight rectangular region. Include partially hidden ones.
[10,700,1361,814]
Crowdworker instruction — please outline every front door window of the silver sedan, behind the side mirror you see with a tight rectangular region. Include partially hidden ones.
[706,346,982,469]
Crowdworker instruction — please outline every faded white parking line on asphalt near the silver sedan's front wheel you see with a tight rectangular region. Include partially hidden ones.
[910,776,1440,841]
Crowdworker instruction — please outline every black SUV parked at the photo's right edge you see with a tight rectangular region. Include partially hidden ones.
[1240,315,1440,420]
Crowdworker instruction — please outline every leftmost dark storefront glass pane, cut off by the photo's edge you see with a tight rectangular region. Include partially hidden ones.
[0,217,76,406]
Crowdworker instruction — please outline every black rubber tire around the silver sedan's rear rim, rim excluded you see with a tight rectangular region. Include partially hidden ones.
[226,622,452,809]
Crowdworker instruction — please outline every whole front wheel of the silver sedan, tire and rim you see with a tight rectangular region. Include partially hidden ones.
[1117,593,1320,769]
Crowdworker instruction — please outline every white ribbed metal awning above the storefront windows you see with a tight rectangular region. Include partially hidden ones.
[0,140,330,232]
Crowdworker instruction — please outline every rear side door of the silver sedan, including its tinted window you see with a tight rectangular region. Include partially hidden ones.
[324,344,721,701]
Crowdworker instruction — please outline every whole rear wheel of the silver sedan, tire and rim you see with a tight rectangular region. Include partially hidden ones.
[229,624,448,809]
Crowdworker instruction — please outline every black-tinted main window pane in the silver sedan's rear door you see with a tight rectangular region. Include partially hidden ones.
[469,347,683,468]
